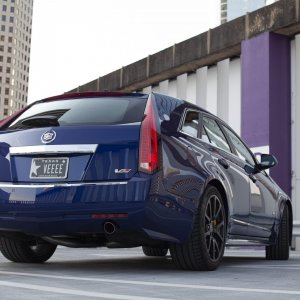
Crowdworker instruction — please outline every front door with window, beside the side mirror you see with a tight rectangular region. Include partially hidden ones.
[223,126,277,238]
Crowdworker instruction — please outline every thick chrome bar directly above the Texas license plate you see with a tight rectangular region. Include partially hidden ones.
[9,144,98,155]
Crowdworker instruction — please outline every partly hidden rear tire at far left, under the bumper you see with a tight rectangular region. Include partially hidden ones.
[0,237,57,263]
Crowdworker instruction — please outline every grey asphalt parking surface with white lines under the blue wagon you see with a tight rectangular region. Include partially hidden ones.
[0,247,300,300]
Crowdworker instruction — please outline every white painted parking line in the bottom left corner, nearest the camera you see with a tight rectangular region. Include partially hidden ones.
[0,280,171,300]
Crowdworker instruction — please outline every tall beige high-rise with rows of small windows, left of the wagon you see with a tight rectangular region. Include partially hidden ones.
[0,0,33,120]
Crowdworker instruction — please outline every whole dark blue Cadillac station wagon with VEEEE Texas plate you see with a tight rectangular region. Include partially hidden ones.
[0,93,292,270]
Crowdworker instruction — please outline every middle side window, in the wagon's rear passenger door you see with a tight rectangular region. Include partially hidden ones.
[203,117,231,152]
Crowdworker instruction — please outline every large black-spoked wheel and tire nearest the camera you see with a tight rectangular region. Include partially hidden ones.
[170,186,226,271]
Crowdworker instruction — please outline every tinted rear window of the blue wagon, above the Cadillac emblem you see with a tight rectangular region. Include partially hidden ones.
[7,97,147,129]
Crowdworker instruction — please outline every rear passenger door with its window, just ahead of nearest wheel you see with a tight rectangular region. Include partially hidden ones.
[201,114,250,237]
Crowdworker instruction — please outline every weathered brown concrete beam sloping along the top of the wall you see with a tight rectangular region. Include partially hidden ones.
[72,0,300,91]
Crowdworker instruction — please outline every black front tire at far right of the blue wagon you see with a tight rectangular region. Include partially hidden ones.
[266,205,290,260]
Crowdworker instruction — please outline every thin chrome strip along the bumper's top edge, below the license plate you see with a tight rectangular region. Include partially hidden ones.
[0,181,128,189]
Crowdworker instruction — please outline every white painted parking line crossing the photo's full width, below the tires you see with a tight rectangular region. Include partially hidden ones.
[0,271,300,299]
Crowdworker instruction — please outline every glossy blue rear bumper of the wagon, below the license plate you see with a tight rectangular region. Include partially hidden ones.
[0,178,149,235]
